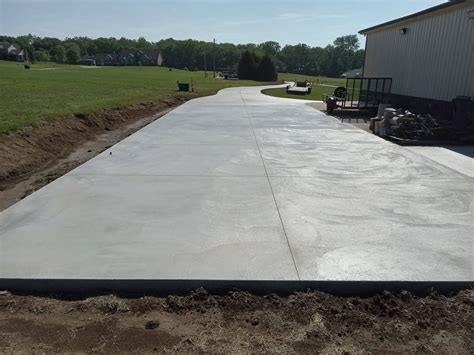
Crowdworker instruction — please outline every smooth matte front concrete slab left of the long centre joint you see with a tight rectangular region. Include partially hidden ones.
[0,175,297,280]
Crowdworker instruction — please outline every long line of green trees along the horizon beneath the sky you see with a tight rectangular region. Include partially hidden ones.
[0,34,364,76]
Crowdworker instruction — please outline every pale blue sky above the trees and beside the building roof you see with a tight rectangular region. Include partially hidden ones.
[0,0,444,47]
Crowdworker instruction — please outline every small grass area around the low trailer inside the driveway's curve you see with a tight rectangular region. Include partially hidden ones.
[263,73,346,101]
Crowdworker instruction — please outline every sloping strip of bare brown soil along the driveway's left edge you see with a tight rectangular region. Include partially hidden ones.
[0,96,193,211]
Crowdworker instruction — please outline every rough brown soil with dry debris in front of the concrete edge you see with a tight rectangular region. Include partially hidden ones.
[0,289,474,354]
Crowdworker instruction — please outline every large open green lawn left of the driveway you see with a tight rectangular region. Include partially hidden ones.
[0,61,265,133]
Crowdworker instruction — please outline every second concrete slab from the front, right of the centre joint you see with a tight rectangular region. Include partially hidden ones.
[261,143,463,181]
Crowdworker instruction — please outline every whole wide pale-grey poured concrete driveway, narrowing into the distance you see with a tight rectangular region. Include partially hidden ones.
[0,88,474,281]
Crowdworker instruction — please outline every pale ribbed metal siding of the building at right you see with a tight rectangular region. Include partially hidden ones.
[364,2,474,101]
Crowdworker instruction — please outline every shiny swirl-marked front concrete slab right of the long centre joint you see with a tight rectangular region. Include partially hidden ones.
[271,177,474,281]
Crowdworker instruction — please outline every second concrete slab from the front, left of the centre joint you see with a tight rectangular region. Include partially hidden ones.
[71,142,265,176]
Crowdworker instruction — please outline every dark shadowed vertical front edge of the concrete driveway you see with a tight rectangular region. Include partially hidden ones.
[0,279,474,297]
